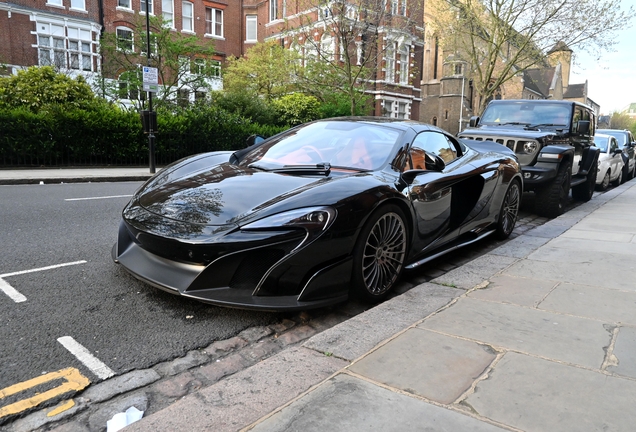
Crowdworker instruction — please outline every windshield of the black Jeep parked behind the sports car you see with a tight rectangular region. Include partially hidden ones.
[480,101,570,127]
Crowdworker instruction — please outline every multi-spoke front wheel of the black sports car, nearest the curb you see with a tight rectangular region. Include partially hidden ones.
[351,204,408,303]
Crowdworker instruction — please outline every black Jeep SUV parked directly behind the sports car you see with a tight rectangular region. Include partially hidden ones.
[458,99,599,217]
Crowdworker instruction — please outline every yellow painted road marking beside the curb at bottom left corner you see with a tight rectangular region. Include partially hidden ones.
[0,368,91,418]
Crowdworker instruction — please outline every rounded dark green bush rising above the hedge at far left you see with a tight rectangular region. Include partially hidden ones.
[0,66,96,112]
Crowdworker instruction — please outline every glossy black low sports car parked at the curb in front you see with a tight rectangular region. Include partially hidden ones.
[112,117,523,311]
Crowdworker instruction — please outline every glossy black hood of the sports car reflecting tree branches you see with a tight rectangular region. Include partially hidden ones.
[137,162,350,226]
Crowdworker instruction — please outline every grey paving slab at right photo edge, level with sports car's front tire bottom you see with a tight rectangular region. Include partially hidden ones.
[539,283,636,325]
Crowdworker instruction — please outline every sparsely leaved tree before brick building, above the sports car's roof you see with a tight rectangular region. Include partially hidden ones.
[283,0,423,115]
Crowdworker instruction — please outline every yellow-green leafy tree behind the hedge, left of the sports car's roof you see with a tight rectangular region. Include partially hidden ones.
[223,42,297,100]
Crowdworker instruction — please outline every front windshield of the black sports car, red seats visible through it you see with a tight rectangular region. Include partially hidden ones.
[240,121,400,171]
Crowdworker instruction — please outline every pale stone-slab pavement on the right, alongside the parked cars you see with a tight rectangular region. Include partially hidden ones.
[3,170,636,432]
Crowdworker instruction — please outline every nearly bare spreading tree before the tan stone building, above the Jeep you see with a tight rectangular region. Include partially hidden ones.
[430,0,634,111]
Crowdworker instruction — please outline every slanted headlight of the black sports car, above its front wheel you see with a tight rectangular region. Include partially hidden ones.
[241,207,336,234]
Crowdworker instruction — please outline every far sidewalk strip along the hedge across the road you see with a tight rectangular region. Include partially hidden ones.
[0,167,160,185]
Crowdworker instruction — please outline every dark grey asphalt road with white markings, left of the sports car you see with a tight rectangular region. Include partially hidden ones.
[0,182,283,389]
